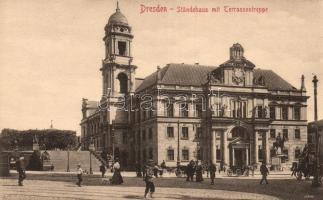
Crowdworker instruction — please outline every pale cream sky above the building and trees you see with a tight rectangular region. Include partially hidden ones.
[0,0,323,133]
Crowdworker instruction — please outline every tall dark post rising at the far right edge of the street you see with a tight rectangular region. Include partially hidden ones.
[312,75,321,187]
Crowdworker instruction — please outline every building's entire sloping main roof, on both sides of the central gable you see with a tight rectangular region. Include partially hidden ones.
[136,63,296,92]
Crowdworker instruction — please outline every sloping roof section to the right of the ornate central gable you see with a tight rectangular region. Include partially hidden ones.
[254,69,297,91]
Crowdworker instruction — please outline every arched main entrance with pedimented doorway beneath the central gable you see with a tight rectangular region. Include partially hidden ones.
[228,126,250,168]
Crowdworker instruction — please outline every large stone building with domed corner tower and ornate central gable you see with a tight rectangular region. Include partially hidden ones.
[81,3,307,168]
